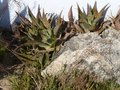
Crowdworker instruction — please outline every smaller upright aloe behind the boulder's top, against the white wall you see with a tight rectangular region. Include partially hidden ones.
[75,2,109,33]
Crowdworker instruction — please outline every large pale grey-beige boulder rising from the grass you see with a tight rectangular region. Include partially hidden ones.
[42,30,120,84]
